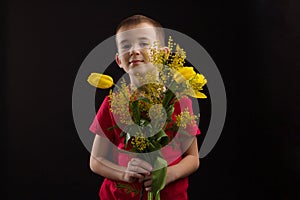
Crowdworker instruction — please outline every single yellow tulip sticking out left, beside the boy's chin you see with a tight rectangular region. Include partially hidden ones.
[87,73,114,89]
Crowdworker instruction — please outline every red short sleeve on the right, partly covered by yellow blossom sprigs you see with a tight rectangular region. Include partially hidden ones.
[173,96,201,135]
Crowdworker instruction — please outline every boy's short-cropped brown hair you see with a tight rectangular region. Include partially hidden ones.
[116,14,165,45]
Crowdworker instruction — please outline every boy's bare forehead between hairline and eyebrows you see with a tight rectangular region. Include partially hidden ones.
[116,23,157,43]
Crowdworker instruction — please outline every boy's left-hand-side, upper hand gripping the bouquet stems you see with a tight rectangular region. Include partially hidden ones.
[124,158,152,184]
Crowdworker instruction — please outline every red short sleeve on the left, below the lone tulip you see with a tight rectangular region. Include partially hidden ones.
[89,96,115,142]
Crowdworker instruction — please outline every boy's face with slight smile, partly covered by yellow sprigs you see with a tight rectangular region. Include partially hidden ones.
[116,23,158,76]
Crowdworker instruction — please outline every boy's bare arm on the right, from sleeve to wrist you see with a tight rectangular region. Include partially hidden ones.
[166,137,200,185]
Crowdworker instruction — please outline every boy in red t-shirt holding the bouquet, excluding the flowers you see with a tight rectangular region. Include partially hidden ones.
[90,15,200,200]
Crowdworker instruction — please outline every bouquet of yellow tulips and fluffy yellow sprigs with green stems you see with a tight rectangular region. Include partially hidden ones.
[88,37,207,200]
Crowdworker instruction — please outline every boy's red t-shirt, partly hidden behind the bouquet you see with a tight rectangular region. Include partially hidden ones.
[90,96,200,200]
